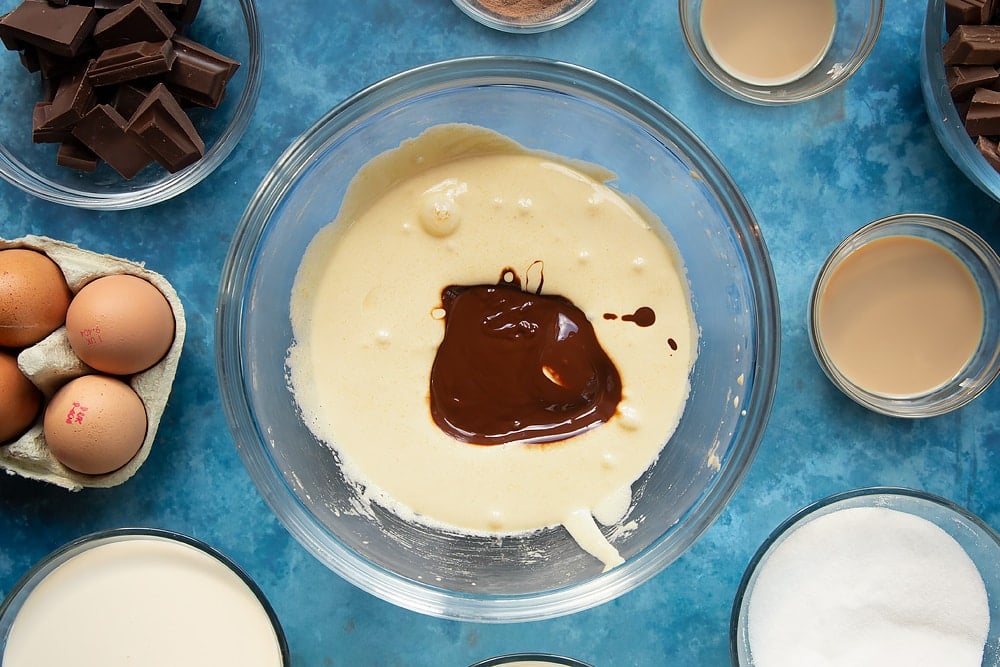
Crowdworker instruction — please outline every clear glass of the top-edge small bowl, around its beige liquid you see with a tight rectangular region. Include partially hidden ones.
[677,0,885,106]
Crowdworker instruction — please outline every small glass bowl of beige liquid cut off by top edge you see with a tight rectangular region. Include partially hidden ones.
[678,0,884,105]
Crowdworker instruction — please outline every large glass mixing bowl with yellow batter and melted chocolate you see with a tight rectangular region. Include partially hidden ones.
[216,57,779,621]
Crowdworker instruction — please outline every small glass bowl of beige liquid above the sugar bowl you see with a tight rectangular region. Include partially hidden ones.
[808,214,1000,417]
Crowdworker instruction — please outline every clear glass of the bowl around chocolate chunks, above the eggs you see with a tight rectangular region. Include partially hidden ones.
[0,0,263,210]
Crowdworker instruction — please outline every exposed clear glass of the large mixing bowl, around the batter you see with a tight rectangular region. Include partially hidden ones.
[215,56,780,622]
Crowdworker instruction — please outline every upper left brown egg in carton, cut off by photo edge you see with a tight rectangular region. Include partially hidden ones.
[0,248,72,347]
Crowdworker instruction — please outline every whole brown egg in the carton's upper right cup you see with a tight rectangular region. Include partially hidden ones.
[66,274,174,375]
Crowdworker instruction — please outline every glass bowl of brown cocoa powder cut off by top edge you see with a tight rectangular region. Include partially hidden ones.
[453,0,597,33]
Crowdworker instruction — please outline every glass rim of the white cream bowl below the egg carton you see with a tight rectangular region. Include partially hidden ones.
[0,527,292,667]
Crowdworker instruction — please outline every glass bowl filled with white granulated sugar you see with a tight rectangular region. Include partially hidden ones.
[730,487,1000,667]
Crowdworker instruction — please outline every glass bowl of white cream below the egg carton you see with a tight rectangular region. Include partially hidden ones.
[0,528,291,667]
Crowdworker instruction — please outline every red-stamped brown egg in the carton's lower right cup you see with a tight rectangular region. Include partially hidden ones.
[42,375,147,475]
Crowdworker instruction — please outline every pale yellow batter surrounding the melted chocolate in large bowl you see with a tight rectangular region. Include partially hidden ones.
[288,125,697,567]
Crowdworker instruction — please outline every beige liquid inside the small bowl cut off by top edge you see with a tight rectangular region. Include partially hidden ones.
[701,0,837,86]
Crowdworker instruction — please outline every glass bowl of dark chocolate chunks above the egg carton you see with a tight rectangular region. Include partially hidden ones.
[0,0,262,210]
